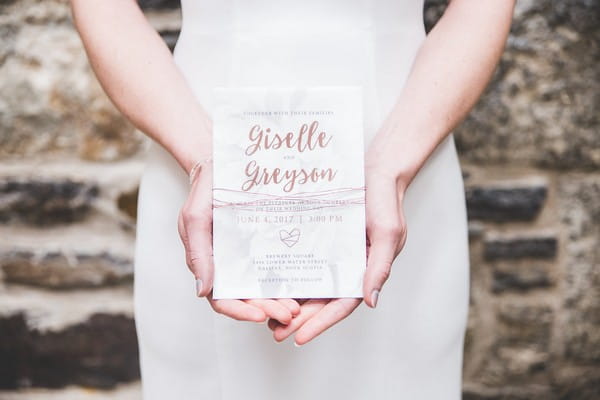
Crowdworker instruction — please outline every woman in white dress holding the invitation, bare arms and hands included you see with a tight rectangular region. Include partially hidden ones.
[71,0,515,400]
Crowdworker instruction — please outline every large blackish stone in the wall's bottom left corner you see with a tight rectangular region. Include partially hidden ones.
[0,313,140,389]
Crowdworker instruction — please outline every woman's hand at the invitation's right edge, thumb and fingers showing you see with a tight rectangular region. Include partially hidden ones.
[268,163,406,345]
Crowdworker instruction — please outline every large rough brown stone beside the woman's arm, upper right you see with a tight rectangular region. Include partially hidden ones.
[455,0,600,170]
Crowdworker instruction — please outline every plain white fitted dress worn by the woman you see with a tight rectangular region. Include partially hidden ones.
[134,0,469,400]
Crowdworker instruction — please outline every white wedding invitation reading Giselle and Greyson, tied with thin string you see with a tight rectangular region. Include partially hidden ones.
[213,86,366,299]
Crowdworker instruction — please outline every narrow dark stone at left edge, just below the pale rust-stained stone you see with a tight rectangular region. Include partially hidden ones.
[0,176,99,226]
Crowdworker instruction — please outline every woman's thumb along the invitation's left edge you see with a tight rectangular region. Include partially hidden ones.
[182,177,214,297]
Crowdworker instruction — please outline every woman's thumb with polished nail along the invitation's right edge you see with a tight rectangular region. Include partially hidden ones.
[363,223,405,308]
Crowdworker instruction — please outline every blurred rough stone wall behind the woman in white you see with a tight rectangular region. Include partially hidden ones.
[0,0,600,400]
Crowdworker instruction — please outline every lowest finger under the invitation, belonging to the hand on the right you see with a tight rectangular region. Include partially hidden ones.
[294,297,362,345]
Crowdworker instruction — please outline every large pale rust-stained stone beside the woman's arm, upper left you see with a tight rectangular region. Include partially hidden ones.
[0,0,145,161]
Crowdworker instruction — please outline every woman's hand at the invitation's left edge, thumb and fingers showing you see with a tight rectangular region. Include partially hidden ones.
[177,158,300,325]
